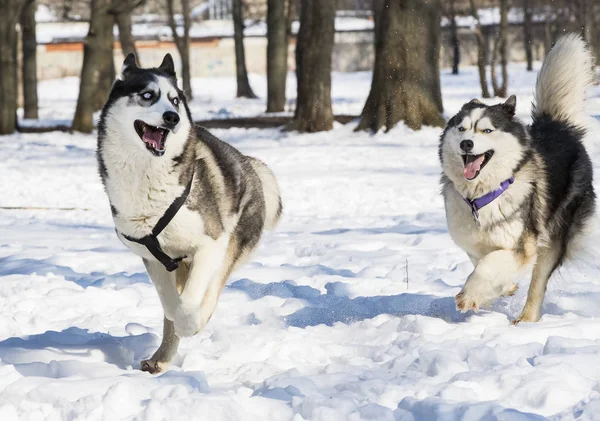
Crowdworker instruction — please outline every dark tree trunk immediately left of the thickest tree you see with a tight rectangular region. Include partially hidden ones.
[288,0,336,133]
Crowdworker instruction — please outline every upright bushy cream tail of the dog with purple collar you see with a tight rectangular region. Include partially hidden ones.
[532,34,594,124]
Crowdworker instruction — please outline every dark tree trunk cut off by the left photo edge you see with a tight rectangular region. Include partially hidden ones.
[0,0,25,135]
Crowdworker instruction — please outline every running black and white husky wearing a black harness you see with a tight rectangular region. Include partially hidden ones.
[97,54,281,373]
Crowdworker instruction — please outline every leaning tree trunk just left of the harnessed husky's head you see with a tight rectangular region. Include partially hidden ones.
[73,0,114,133]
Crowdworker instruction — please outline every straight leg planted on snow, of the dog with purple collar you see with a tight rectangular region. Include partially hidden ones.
[513,244,565,324]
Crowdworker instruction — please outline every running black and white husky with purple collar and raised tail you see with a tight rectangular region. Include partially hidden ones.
[440,35,595,322]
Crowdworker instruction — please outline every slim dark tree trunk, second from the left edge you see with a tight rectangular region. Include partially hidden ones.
[21,0,38,118]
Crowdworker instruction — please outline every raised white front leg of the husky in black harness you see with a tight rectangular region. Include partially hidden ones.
[173,238,227,338]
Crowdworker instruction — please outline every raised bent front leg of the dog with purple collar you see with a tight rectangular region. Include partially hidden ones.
[456,250,526,312]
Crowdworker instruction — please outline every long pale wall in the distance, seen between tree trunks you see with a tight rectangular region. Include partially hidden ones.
[38,19,545,80]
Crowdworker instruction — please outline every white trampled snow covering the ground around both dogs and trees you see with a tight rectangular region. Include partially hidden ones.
[0,65,600,421]
